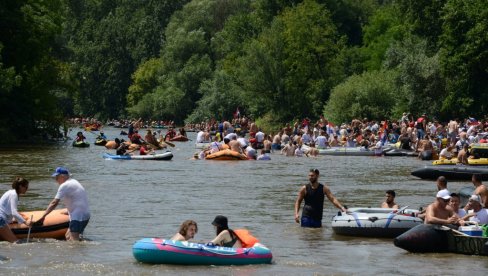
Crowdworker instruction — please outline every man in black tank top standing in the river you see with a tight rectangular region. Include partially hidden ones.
[295,169,346,228]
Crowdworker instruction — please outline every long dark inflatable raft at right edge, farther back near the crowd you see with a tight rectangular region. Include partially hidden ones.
[412,165,488,180]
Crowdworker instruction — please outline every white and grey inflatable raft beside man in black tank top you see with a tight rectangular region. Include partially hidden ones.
[332,208,423,238]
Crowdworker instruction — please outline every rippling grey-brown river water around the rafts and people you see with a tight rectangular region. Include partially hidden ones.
[0,128,488,275]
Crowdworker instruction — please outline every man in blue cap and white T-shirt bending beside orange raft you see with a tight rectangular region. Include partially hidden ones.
[36,167,90,241]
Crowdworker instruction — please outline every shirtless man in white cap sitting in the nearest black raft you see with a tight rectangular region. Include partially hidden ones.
[424,190,462,224]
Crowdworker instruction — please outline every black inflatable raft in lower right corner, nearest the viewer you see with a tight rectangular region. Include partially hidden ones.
[393,224,488,256]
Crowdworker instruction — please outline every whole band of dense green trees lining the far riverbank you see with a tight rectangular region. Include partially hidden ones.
[0,0,488,137]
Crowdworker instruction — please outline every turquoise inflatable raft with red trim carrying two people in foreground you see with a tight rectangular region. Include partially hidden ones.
[132,238,273,265]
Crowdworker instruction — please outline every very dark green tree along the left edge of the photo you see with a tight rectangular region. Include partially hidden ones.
[0,0,69,142]
